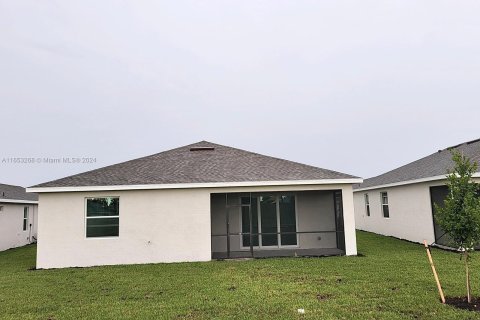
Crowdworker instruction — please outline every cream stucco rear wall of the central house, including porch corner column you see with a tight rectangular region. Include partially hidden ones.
[37,185,356,268]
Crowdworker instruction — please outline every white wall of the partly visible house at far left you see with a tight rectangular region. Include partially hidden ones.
[0,202,38,251]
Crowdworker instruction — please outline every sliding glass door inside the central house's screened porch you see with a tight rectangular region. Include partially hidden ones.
[242,194,297,248]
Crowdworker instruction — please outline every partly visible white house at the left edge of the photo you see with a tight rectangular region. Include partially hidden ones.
[0,184,38,251]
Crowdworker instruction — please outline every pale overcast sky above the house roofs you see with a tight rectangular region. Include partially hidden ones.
[0,0,480,186]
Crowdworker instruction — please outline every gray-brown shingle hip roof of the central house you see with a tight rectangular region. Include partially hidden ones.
[33,141,357,188]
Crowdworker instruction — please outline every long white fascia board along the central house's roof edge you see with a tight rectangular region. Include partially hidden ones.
[27,178,363,193]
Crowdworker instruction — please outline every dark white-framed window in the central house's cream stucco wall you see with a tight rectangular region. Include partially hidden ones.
[86,197,120,238]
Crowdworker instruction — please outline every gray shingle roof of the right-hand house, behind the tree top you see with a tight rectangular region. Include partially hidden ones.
[354,139,480,190]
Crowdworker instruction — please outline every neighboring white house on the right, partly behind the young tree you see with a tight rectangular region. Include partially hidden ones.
[354,139,480,245]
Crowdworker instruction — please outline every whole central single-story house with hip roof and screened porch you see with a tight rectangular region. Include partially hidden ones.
[29,141,362,268]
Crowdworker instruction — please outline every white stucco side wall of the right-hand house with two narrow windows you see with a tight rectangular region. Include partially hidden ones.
[354,179,480,243]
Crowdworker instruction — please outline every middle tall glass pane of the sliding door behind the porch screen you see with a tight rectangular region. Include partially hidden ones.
[260,196,278,246]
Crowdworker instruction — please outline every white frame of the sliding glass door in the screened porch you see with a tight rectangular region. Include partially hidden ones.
[239,193,300,250]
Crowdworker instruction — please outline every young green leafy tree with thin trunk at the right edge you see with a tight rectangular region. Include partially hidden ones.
[435,151,480,303]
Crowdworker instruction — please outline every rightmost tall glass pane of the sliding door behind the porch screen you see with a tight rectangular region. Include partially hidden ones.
[279,196,297,246]
